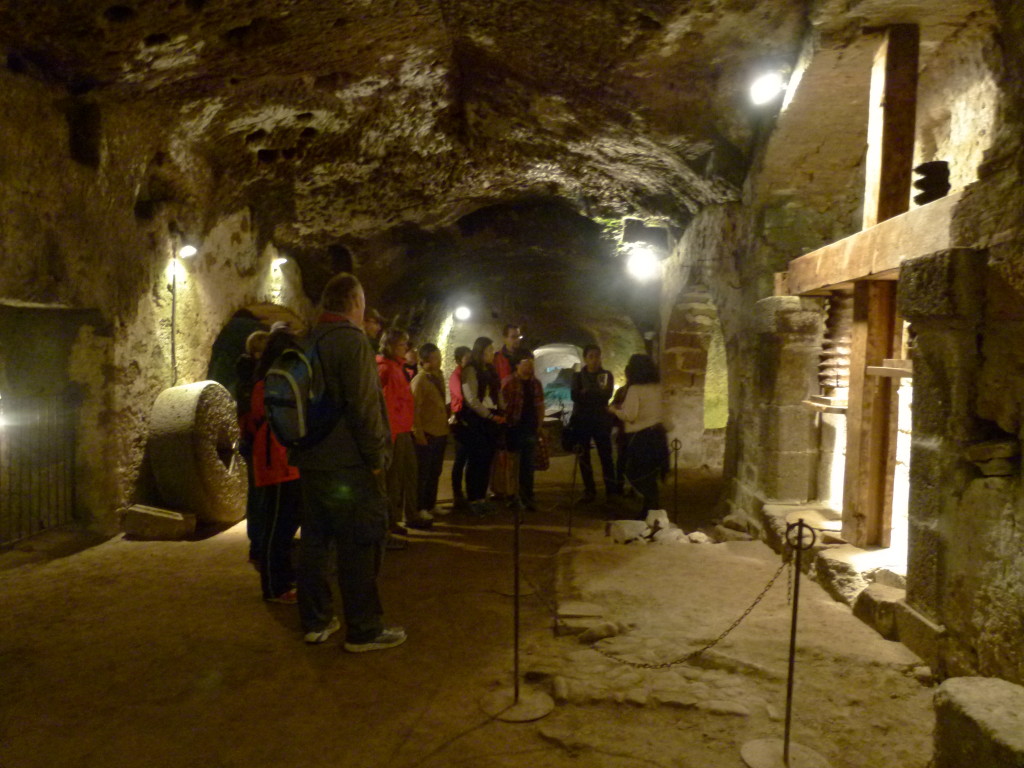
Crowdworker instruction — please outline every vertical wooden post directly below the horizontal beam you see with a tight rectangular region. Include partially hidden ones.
[843,281,896,547]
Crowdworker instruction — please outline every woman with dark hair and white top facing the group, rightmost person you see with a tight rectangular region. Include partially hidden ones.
[611,354,669,518]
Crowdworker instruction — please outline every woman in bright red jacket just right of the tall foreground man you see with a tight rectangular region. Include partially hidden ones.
[377,328,433,528]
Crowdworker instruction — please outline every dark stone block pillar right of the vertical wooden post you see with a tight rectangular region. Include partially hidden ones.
[899,249,986,666]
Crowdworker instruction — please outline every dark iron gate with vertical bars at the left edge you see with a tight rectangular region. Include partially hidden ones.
[0,394,77,547]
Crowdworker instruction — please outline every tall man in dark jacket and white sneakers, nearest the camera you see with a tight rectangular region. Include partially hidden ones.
[290,272,406,653]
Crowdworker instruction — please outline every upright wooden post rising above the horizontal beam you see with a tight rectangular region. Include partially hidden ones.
[863,24,920,229]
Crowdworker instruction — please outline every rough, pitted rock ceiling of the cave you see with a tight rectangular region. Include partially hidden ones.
[0,0,805,243]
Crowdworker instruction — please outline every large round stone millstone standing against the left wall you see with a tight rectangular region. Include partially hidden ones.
[147,381,247,524]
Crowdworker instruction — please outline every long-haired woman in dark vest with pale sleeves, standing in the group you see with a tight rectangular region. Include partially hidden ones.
[460,336,504,516]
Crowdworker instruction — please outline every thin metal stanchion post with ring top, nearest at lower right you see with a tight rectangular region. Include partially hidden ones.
[740,518,828,768]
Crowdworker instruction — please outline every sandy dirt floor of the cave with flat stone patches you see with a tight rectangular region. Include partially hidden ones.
[0,458,933,768]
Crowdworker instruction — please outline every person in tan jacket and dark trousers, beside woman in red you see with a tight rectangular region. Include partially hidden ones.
[412,344,449,519]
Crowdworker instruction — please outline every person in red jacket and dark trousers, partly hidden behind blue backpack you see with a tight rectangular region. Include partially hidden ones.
[243,329,302,604]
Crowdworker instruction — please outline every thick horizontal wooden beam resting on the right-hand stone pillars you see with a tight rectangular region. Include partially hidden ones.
[776,193,961,296]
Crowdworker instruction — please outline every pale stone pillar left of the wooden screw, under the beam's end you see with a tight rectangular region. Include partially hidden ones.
[754,296,824,502]
